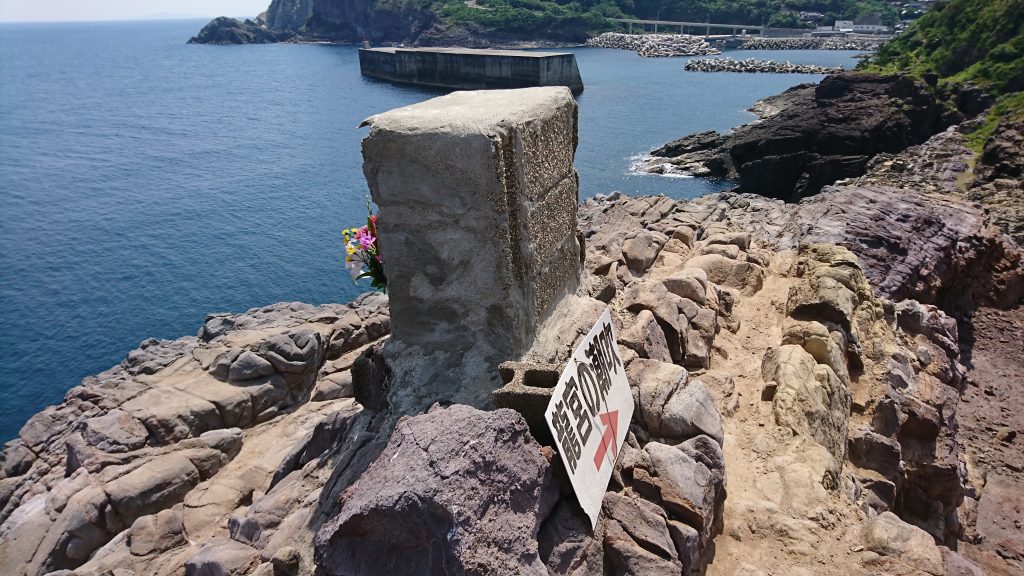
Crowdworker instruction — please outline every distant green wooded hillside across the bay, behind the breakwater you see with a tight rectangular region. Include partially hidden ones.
[435,0,899,40]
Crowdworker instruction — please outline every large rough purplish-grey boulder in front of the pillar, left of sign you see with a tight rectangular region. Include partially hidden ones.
[315,405,557,576]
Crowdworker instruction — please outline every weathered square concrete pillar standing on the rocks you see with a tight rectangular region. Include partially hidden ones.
[362,87,581,407]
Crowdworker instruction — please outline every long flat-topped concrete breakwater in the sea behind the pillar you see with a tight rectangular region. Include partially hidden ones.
[359,48,583,93]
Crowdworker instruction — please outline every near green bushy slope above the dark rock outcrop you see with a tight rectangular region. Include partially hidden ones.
[862,0,1024,93]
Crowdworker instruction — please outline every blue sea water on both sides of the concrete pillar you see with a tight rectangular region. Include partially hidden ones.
[0,20,853,442]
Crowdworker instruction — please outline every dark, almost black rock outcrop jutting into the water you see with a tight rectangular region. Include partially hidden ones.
[641,74,963,202]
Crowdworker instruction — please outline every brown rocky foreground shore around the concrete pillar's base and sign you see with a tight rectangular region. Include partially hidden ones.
[0,114,1024,576]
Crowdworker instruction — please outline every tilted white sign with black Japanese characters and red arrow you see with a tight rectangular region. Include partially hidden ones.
[544,308,633,528]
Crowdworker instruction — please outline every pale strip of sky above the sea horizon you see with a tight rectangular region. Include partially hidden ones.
[0,0,270,22]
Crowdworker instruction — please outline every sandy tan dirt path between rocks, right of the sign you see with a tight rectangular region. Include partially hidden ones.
[708,266,860,576]
